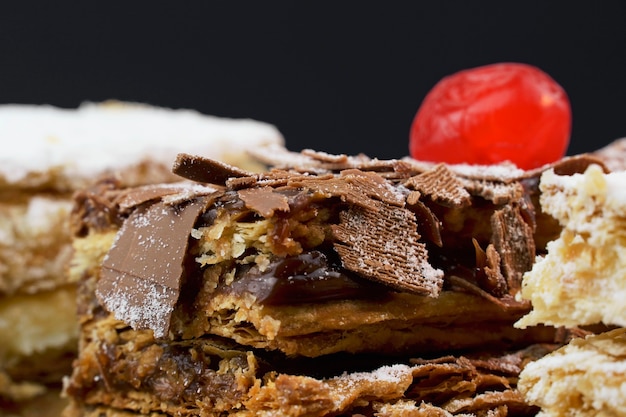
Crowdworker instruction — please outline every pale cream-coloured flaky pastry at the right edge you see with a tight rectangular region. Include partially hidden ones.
[516,140,626,416]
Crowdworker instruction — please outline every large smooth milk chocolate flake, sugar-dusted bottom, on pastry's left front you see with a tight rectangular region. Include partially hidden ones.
[96,197,210,337]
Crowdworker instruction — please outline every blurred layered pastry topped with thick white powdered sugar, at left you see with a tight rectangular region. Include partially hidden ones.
[0,102,283,410]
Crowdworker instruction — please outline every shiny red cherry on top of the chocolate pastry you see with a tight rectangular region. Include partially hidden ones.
[409,63,572,169]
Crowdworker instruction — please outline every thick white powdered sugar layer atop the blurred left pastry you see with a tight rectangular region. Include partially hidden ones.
[0,103,284,183]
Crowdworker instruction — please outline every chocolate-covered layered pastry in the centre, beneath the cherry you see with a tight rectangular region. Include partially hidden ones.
[64,144,602,416]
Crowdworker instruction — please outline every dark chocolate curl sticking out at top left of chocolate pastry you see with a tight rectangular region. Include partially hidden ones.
[172,153,253,185]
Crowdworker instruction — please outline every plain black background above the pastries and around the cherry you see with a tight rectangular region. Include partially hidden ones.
[0,0,626,158]
